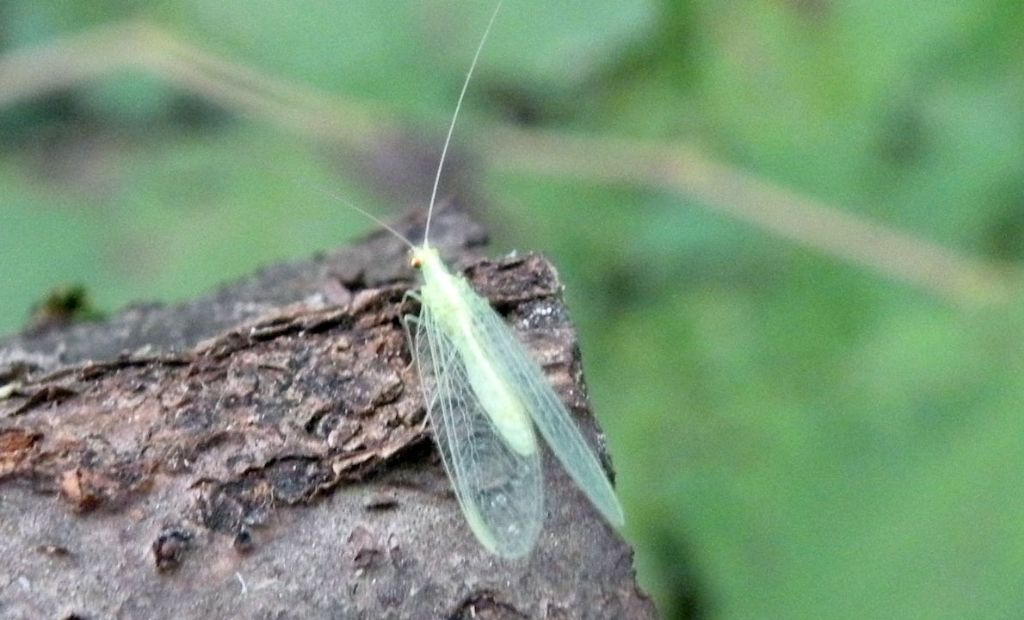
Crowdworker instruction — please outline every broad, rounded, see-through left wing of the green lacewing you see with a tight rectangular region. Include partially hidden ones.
[413,305,544,557]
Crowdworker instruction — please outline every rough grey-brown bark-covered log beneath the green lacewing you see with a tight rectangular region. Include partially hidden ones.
[0,210,655,620]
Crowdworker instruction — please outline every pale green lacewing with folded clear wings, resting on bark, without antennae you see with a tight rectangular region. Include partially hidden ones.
[408,246,624,557]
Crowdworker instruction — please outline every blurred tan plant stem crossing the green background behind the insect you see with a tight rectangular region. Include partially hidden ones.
[0,22,1013,306]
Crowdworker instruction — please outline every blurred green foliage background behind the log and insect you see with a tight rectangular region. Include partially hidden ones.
[0,0,1024,618]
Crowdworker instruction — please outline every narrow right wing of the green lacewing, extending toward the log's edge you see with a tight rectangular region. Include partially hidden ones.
[466,284,626,527]
